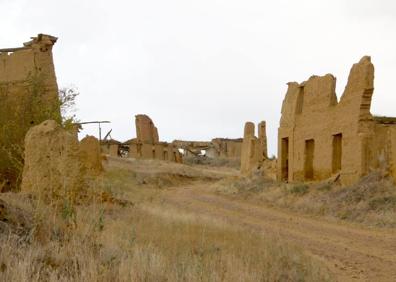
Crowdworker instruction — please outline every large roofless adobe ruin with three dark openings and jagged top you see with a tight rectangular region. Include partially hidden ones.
[277,56,396,184]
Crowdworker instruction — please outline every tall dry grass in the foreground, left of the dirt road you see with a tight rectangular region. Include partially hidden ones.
[0,162,331,281]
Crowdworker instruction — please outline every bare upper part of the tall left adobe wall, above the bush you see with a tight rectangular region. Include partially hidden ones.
[0,34,61,121]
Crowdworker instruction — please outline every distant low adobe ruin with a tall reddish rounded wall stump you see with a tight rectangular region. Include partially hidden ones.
[126,115,182,163]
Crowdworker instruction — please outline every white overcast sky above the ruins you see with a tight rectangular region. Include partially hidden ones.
[0,0,396,153]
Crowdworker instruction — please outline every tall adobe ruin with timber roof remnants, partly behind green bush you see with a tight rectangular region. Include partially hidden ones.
[0,34,61,190]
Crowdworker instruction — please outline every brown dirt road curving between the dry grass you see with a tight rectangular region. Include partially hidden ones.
[164,182,396,281]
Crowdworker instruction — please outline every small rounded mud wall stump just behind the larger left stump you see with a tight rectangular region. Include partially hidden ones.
[80,135,103,175]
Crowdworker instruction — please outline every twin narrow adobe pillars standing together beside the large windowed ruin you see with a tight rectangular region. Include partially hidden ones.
[241,121,268,175]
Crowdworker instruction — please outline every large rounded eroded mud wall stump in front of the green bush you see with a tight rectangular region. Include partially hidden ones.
[21,120,83,202]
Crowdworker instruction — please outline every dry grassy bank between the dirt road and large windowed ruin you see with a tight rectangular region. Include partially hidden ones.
[216,172,396,228]
